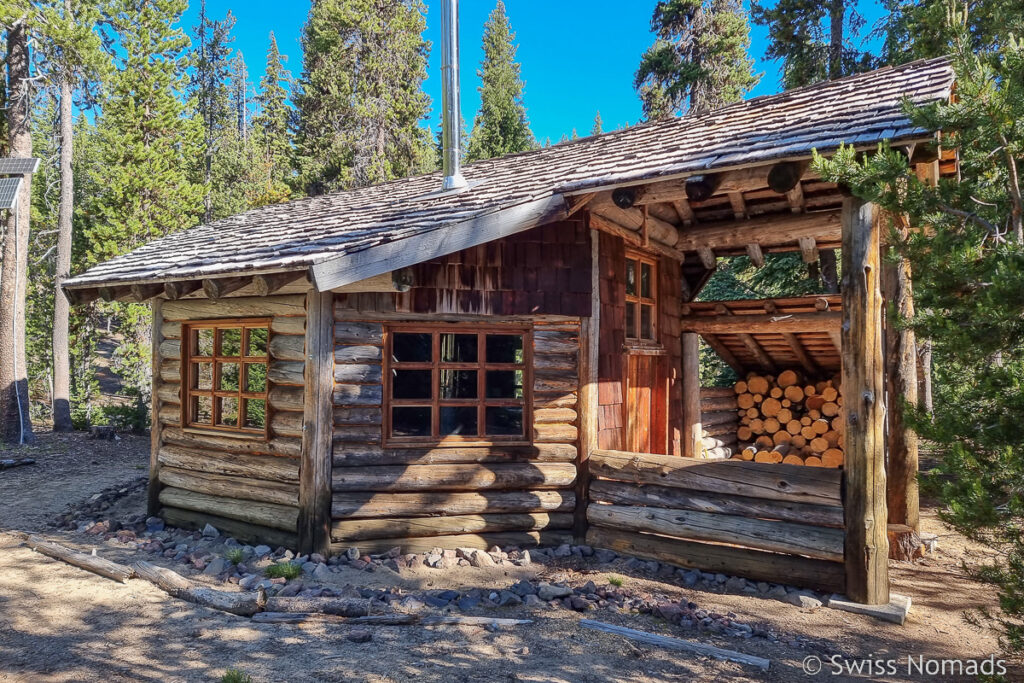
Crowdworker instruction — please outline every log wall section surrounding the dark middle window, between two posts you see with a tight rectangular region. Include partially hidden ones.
[331,309,580,552]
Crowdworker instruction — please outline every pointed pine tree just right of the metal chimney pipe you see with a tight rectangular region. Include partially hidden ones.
[466,0,536,161]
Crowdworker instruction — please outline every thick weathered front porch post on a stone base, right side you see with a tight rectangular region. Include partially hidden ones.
[841,197,889,605]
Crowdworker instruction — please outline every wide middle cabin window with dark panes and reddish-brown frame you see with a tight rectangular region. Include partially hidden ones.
[385,326,529,441]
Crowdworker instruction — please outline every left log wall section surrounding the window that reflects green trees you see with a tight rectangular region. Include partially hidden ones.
[151,294,306,548]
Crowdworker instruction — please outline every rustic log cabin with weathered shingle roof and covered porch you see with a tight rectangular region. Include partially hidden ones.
[65,54,955,603]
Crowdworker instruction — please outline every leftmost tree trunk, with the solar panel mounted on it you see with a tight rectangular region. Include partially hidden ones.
[0,18,35,443]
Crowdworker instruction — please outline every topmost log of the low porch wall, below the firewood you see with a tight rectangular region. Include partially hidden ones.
[590,451,841,505]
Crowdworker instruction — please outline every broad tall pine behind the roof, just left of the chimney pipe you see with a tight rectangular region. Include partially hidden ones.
[295,0,430,194]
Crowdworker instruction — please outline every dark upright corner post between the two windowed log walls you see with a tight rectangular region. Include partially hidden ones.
[298,291,334,555]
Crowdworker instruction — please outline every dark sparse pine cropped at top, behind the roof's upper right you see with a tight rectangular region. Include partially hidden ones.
[751,0,876,89]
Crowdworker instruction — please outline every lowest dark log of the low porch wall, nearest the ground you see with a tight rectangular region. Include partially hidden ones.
[587,526,846,593]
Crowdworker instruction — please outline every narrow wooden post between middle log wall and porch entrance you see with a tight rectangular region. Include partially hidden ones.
[572,230,601,543]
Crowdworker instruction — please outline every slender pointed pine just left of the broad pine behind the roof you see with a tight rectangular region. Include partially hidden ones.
[253,32,294,205]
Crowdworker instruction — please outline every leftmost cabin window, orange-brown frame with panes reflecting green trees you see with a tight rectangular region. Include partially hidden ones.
[182,319,269,437]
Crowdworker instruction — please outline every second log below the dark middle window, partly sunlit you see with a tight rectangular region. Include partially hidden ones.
[332,462,577,492]
